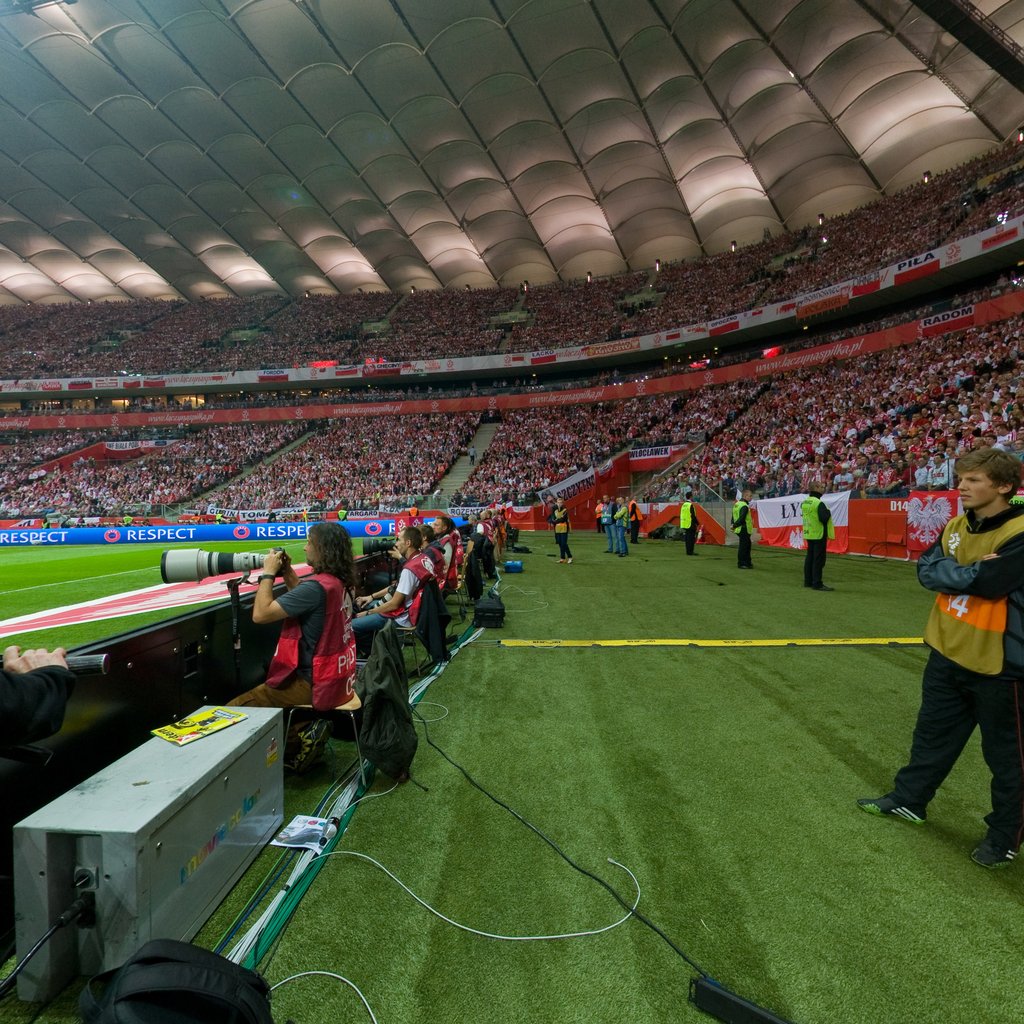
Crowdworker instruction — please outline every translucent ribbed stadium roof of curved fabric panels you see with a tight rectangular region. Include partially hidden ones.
[0,0,1024,303]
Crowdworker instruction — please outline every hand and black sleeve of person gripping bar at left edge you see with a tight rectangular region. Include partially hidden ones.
[0,646,75,746]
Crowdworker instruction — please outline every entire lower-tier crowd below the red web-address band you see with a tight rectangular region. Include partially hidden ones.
[8,307,1024,515]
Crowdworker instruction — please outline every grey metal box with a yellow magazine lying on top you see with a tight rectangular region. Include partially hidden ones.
[14,708,284,1000]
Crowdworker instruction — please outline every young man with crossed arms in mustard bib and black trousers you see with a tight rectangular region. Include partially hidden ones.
[857,447,1024,867]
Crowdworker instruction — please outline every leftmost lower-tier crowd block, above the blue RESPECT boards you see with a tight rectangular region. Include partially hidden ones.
[0,423,305,517]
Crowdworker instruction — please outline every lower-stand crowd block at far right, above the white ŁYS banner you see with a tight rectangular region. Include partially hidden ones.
[700,317,1024,497]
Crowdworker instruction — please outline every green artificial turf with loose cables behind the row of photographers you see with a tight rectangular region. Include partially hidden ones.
[0,534,1024,1024]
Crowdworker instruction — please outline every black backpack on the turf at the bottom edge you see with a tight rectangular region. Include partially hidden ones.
[78,939,273,1024]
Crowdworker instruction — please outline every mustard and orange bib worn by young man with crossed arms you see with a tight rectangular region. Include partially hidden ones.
[925,515,1024,676]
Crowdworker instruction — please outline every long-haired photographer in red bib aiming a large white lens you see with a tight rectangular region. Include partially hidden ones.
[230,522,360,772]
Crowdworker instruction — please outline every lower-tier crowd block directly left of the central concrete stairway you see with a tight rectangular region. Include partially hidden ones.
[208,413,479,510]
